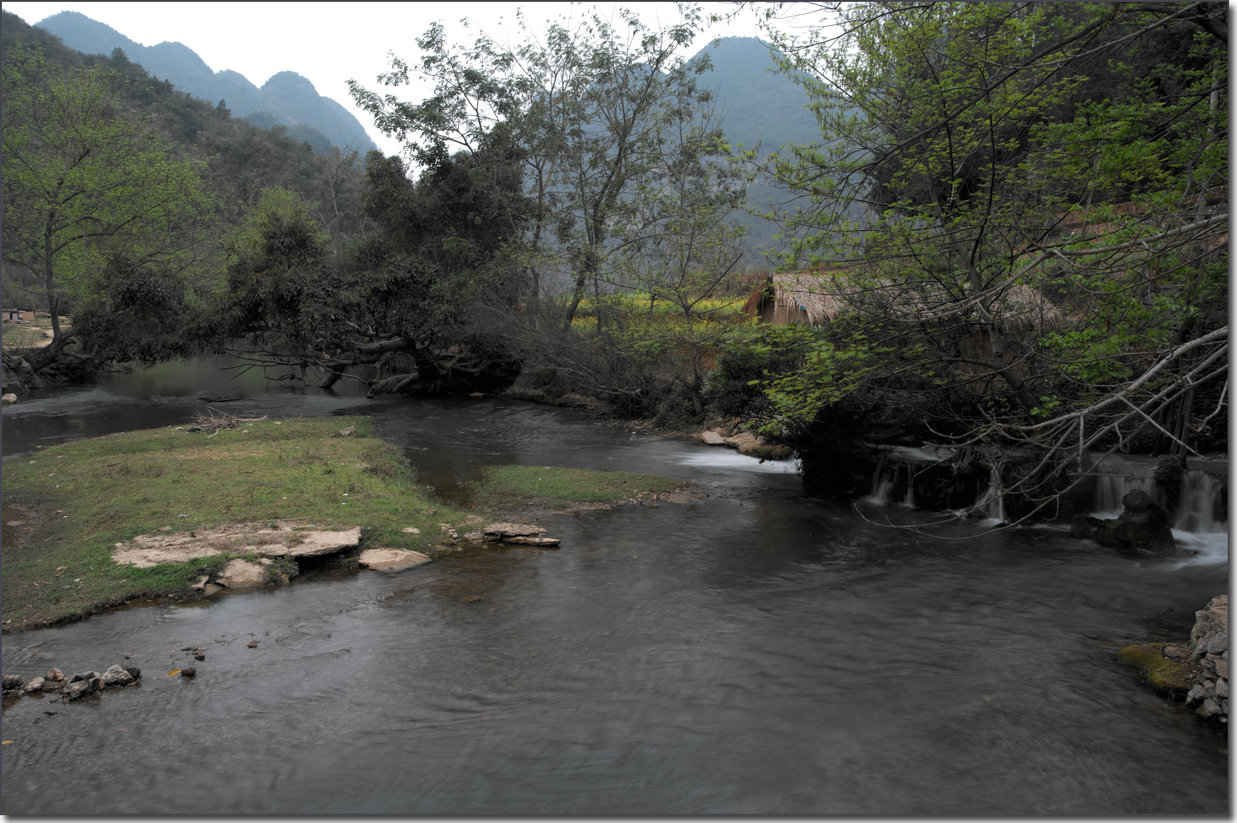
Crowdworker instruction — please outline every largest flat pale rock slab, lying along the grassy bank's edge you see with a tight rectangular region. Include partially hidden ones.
[111,521,361,568]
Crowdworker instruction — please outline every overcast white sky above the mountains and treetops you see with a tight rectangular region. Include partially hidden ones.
[4,1,760,155]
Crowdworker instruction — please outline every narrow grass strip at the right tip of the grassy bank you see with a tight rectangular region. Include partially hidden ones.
[470,465,684,509]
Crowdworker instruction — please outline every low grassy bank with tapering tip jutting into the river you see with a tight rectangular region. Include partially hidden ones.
[0,417,683,631]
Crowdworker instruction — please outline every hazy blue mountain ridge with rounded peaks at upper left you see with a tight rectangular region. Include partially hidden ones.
[36,11,376,153]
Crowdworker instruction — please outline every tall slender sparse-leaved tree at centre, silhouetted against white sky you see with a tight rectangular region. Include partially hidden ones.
[350,6,731,328]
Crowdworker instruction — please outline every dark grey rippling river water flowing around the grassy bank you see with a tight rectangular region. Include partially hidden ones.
[2,361,1228,817]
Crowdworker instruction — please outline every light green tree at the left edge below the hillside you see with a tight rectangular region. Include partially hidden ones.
[2,46,210,370]
